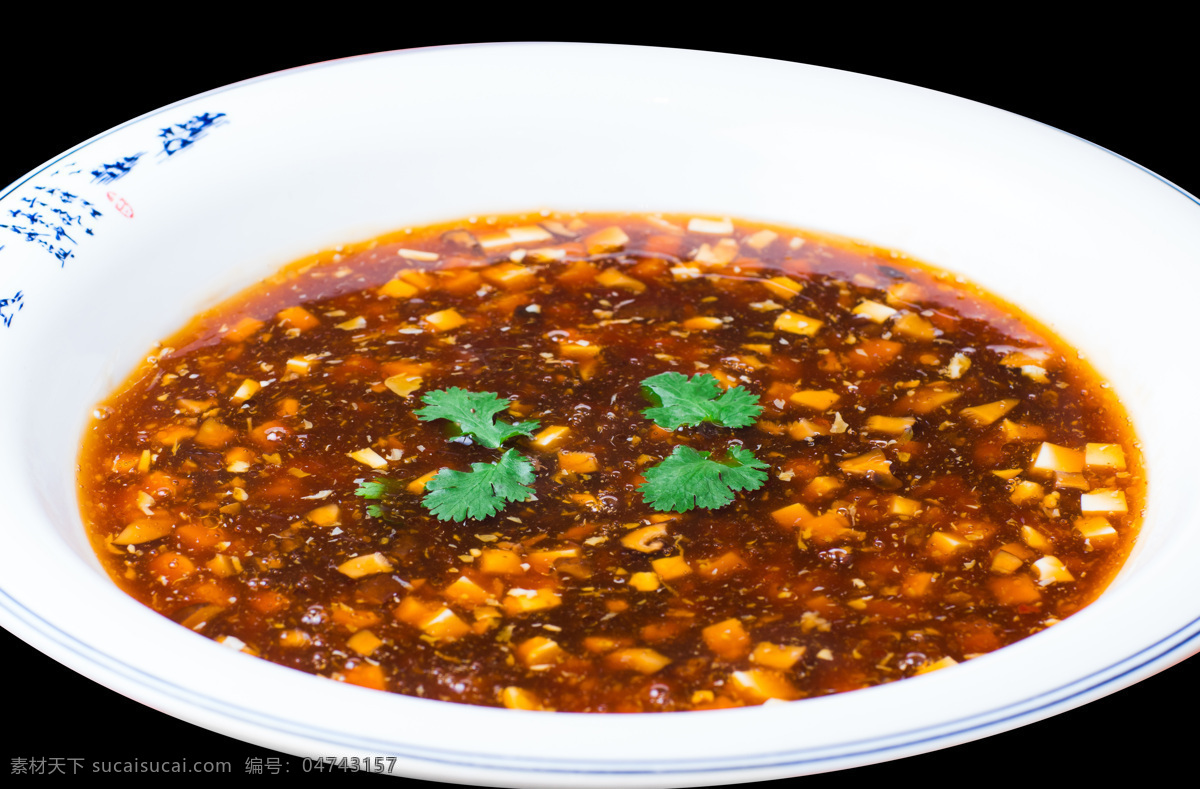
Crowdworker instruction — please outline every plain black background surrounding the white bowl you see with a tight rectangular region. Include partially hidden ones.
[0,21,1200,787]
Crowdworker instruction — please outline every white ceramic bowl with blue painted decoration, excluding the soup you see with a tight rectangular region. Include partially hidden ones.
[0,46,1200,785]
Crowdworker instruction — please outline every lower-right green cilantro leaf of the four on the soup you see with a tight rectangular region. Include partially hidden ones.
[638,445,768,512]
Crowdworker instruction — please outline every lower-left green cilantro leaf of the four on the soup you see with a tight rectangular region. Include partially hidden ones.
[421,450,534,522]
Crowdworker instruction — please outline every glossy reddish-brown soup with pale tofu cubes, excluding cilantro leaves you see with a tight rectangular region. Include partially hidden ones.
[79,215,1144,711]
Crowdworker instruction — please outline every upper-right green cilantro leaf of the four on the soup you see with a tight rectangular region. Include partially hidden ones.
[642,373,762,430]
